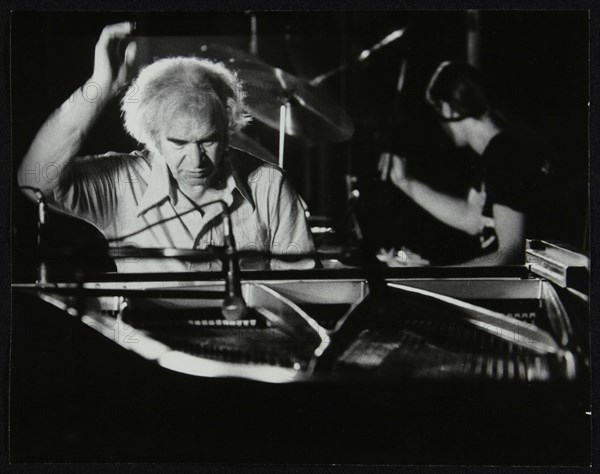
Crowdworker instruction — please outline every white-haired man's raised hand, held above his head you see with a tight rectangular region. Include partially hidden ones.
[91,22,136,97]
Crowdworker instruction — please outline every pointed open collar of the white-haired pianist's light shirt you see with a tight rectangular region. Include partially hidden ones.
[136,150,256,217]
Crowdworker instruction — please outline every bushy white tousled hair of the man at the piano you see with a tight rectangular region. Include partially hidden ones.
[121,56,251,148]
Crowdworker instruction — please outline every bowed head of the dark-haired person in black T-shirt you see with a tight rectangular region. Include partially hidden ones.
[425,61,491,146]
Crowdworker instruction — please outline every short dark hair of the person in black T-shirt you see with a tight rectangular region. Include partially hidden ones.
[426,61,491,118]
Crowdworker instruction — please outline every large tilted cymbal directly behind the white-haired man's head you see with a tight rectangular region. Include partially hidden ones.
[200,43,354,142]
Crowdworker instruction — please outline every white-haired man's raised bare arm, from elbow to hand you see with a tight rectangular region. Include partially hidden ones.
[17,22,136,196]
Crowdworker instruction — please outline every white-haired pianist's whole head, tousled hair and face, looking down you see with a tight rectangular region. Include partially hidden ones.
[121,57,250,191]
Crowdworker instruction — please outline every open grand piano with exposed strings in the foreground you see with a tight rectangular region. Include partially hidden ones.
[10,235,591,465]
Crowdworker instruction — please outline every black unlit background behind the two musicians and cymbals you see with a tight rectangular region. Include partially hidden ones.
[11,11,589,270]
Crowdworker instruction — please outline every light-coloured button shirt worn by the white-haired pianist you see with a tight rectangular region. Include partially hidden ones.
[54,147,315,272]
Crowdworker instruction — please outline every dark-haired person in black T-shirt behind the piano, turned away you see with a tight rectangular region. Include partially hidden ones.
[378,62,549,266]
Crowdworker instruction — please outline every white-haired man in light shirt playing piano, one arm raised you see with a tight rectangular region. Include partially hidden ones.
[18,22,315,272]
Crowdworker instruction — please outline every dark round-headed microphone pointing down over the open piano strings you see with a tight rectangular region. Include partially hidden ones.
[220,201,248,320]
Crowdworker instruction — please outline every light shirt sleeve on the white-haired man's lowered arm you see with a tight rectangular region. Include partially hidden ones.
[269,170,317,269]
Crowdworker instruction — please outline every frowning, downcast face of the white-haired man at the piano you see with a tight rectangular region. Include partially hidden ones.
[158,104,227,192]
